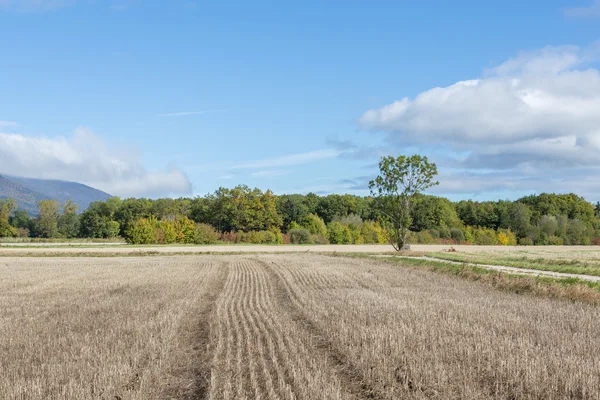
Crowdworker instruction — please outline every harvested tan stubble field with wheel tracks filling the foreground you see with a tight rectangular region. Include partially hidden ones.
[0,254,600,400]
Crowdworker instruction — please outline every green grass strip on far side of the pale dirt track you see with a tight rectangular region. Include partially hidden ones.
[427,253,600,276]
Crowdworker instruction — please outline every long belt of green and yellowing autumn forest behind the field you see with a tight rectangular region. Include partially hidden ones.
[0,185,600,245]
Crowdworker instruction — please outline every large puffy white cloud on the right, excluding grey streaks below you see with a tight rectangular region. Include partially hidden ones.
[359,46,600,165]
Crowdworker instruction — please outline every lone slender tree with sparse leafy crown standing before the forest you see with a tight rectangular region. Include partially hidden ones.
[369,154,439,251]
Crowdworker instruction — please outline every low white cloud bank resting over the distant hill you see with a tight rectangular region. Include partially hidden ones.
[0,128,191,197]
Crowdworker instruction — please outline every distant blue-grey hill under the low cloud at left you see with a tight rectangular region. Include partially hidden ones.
[0,175,112,215]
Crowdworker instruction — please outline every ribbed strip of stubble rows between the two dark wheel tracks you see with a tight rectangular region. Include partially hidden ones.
[209,260,348,400]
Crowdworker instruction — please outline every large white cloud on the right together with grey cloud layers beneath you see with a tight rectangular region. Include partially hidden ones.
[359,44,600,198]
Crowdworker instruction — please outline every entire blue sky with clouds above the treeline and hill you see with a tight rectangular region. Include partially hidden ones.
[0,0,600,201]
